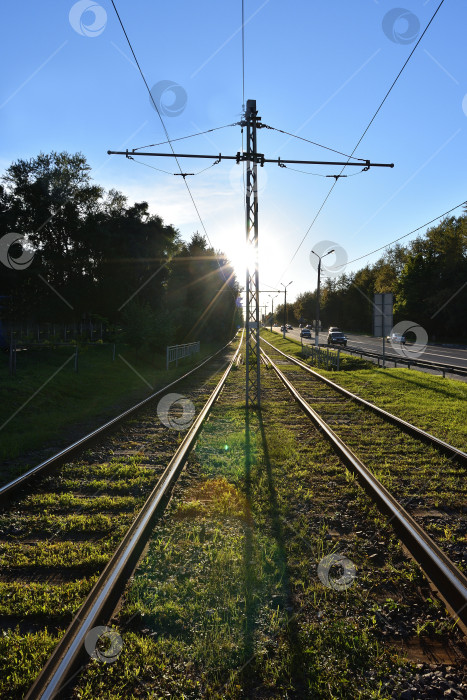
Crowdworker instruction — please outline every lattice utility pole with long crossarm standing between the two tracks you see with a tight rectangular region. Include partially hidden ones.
[107,100,394,408]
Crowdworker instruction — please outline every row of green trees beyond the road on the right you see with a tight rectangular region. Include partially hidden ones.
[294,215,467,339]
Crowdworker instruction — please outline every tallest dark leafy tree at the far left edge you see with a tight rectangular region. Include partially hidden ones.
[1,152,103,318]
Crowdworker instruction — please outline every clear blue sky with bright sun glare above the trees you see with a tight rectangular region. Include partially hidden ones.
[0,0,467,308]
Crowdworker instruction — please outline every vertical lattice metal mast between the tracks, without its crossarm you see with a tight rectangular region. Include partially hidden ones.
[245,100,261,408]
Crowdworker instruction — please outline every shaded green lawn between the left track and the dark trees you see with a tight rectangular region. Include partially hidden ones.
[0,343,228,474]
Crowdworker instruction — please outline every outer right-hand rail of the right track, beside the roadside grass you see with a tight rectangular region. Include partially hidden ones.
[261,338,467,466]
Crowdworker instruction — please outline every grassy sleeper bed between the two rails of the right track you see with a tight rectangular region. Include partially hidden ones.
[265,341,467,570]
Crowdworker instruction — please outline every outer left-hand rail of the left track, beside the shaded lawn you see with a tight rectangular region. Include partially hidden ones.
[0,339,239,503]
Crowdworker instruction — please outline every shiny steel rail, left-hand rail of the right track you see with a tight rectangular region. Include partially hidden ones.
[261,350,467,631]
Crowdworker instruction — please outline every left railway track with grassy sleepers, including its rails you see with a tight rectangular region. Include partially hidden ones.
[0,334,241,697]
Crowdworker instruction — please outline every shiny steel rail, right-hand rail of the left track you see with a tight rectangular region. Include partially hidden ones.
[25,333,243,700]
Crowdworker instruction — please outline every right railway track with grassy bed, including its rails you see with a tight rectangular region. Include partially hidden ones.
[262,339,467,631]
